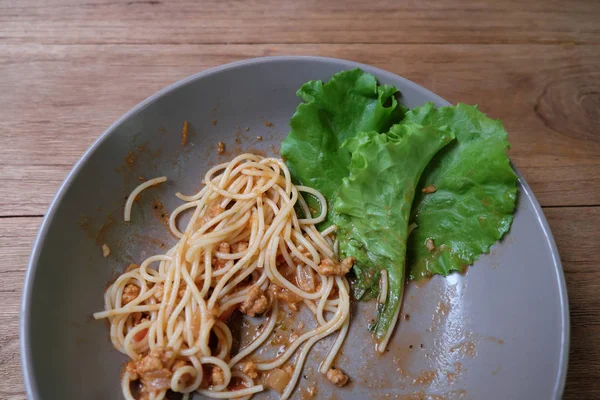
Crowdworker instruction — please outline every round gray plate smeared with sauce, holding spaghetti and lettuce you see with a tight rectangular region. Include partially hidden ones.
[21,57,569,399]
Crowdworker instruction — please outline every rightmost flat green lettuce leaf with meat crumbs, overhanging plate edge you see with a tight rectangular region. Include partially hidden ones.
[401,103,517,279]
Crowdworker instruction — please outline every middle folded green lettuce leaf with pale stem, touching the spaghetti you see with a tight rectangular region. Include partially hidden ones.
[334,124,454,339]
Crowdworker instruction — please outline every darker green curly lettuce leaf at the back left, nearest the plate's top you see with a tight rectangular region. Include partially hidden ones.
[281,69,406,225]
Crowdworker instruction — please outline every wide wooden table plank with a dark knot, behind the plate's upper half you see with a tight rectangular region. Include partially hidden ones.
[0,44,600,216]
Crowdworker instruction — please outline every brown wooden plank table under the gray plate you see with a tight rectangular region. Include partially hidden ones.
[0,0,600,399]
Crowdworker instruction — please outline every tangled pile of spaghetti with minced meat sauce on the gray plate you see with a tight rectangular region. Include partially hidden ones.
[94,154,354,400]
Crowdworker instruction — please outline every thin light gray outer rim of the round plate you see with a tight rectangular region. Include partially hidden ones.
[19,56,570,400]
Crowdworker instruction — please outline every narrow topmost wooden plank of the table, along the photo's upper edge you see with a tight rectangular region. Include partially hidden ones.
[0,0,600,45]
